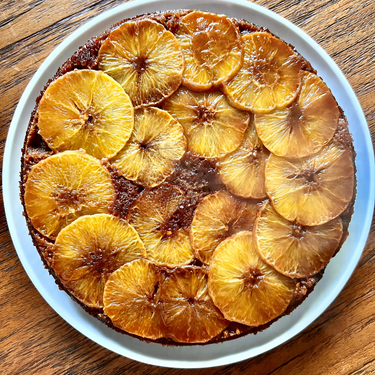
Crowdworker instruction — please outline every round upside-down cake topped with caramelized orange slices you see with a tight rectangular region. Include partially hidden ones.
[20,10,356,345]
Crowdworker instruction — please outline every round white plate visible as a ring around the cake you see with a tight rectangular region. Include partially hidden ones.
[3,0,375,368]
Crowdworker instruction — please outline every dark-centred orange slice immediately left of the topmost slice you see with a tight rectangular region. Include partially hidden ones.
[98,19,184,107]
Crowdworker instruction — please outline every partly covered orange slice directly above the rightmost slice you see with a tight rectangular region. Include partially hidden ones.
[255,72,340,158]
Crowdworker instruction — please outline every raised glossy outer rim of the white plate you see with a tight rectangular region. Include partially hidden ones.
[2,0,375,368]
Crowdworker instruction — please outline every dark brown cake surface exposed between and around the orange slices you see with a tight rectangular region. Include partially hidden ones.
[20,10,356,346]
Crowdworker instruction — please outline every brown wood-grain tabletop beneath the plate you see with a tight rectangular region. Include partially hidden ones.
[0,0,375,375]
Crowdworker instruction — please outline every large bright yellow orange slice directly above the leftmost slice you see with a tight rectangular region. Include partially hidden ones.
[38,70,134,159]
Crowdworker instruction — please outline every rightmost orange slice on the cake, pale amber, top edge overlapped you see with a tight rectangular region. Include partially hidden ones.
[266,140,354,225]
